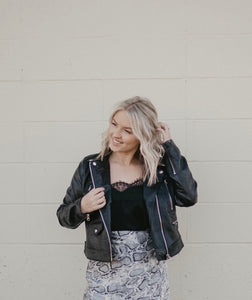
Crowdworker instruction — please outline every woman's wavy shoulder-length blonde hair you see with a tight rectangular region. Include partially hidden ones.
[99,96,164,186]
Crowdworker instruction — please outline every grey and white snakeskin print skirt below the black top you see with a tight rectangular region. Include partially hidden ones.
[83,231,169,300]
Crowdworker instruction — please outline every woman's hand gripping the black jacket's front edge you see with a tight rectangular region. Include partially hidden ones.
[81,187,106,213]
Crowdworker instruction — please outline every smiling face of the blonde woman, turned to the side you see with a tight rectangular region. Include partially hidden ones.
[109,110,139,154]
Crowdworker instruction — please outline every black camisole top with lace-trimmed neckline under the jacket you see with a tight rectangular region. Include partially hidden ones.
[111,179,149,231]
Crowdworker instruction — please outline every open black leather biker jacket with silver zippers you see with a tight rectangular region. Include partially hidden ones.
[57,140,197,262]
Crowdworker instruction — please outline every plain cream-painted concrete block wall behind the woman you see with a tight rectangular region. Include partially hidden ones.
[0,0,252,300]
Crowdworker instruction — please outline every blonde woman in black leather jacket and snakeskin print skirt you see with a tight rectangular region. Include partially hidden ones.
[57,97,197,300]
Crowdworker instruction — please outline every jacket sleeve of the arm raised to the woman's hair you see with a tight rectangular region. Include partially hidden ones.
[163,140,198,206]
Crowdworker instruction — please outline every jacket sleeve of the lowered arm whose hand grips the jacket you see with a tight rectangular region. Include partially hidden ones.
[57,161,87,229]
